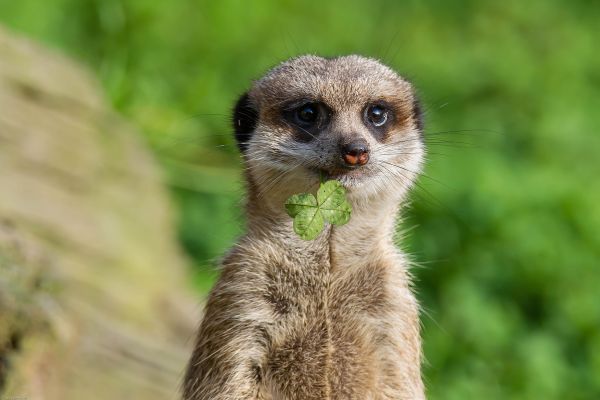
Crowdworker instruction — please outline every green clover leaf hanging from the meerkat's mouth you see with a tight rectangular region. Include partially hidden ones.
[285,180,352,240]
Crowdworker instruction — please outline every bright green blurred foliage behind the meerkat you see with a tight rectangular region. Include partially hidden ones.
[0,0,600,400]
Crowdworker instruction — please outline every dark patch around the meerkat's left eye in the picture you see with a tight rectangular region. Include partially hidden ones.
[283,100,331,142]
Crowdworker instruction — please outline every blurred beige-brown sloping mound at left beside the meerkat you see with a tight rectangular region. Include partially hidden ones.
[0,28,198,400]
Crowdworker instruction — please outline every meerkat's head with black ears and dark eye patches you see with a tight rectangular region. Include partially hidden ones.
[233,56,424,203]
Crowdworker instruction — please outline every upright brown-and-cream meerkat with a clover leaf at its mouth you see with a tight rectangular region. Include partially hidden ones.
[183,55,425,400]
